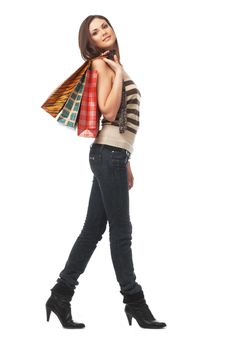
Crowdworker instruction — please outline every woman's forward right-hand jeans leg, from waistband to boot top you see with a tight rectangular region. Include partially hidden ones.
[90,145,142,295]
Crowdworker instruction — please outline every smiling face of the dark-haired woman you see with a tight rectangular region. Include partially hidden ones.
[89,18,116,51]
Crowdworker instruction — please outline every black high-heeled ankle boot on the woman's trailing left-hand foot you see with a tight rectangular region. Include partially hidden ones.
[45,282,85,328]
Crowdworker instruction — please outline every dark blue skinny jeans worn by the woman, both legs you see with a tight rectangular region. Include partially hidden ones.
[57,143,142,295]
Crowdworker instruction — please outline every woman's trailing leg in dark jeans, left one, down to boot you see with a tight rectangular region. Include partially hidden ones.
[57,176,107,289]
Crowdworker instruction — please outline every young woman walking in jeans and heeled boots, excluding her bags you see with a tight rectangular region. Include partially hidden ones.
[46,15,166,328]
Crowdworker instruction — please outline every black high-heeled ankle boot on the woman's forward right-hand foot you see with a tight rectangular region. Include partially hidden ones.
[123,291,167,328]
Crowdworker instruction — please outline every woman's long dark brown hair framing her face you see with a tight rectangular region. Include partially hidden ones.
[78,15,120,62]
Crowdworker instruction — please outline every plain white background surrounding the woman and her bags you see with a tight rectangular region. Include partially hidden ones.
[0,0,233,350]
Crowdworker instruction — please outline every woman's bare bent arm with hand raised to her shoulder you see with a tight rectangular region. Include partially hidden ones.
[92,55,123,121]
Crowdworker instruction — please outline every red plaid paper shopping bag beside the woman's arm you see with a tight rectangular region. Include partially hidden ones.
[77,69,101,137]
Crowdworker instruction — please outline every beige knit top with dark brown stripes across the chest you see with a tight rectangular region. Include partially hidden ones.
[94,76,141,153]
